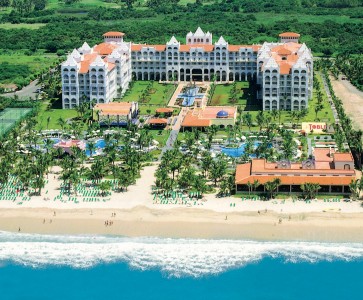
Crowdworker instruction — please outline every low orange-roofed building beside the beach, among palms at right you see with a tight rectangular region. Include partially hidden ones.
[235,149,356,193]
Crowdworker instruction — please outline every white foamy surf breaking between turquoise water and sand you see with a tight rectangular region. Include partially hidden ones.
[0,232,363,277]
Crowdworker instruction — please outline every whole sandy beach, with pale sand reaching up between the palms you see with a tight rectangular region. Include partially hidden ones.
[0,166,363,242]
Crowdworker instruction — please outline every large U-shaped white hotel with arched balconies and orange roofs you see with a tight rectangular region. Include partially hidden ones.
[61,28,313,110]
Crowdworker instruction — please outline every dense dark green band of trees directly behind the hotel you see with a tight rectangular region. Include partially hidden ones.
[0,8,363,55]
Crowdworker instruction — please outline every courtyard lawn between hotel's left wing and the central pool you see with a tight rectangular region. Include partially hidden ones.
[121,81,175,108]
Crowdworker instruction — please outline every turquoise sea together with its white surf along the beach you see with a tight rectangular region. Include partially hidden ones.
[0,232,363,300]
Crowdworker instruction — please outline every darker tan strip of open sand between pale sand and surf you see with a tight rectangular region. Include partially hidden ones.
[0,206,363,242]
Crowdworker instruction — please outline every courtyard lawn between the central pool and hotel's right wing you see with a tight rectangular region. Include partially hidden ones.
[209,81,253,106]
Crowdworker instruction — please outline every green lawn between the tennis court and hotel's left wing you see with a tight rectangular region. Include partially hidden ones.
[37,102,77,130]
